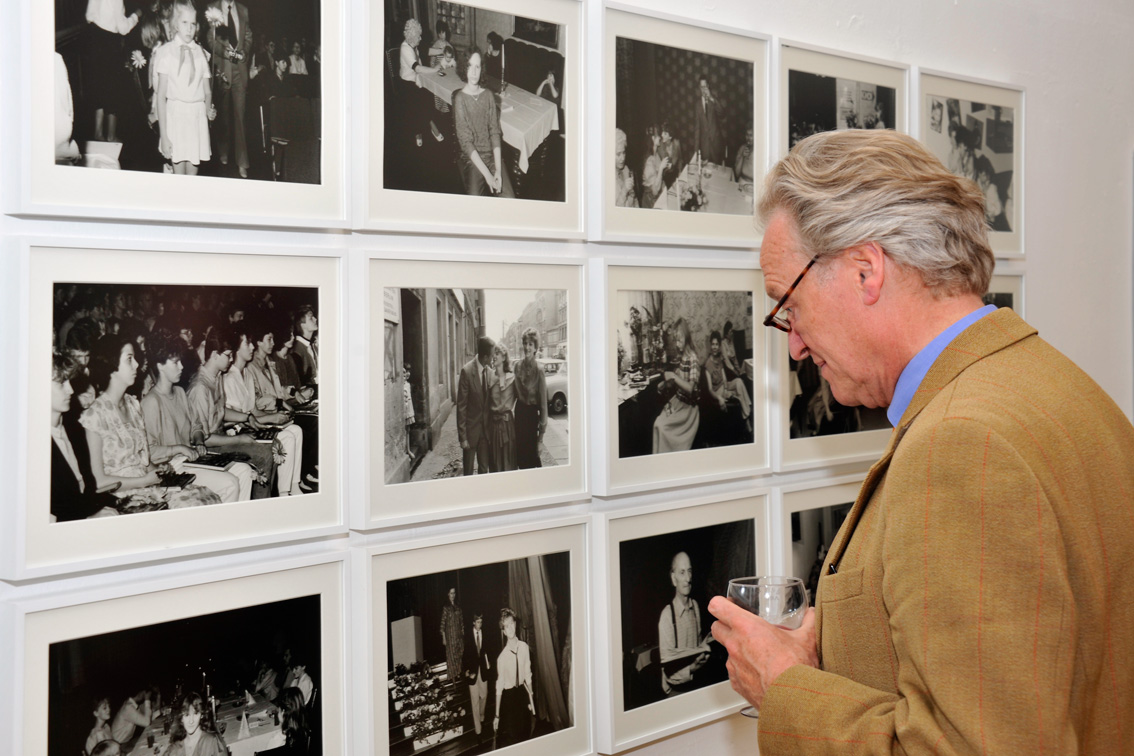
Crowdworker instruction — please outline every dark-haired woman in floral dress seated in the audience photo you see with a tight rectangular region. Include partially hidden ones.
[79,334,220,509]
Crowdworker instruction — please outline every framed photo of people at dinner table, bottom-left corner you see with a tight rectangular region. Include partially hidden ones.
[13,557,347,756]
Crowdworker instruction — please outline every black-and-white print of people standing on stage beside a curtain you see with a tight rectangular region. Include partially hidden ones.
[385,552,574,756]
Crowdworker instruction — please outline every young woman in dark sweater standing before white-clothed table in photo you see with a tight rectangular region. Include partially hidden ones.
[452,49,516,197]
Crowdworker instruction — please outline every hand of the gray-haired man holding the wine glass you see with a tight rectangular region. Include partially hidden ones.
[709,596,819,708]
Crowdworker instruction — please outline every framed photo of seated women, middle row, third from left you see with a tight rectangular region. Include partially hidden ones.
[595,263,768,492]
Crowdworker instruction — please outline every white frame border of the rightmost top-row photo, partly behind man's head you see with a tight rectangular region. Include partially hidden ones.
[909,68,1027,258]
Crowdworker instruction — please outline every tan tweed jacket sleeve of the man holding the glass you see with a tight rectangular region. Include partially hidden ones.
[760,413,1077,756]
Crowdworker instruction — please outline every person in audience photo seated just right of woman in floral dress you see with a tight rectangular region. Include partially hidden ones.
[142,331,254,501]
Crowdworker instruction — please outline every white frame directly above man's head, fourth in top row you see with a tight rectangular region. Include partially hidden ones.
[775,41,909,156]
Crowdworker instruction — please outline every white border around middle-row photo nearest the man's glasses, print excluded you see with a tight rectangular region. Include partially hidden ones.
[589,257,771,496]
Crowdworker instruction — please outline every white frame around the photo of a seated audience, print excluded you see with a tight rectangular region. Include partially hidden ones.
[0,236,348,580]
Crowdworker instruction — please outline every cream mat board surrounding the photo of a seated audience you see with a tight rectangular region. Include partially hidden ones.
[16,246,342,572]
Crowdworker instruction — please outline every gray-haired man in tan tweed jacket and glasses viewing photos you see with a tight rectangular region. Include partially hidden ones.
[709,126,1134,756]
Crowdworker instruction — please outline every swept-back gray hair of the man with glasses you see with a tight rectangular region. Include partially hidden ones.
[759,129,996,296]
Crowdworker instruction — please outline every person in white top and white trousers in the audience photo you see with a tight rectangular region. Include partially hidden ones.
[225,321,303,496]
